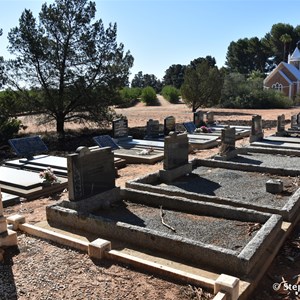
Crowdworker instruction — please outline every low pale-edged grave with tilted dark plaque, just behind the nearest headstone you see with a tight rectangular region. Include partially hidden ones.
[93,135,164,164]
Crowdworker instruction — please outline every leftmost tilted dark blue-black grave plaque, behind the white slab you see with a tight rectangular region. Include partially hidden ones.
[8,136,48,160]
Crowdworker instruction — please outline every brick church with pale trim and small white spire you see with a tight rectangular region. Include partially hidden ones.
[264,42,300,99]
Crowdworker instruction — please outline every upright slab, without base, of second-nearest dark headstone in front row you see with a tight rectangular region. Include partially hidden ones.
[163,132,189,170]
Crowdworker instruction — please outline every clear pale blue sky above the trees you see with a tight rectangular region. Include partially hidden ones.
[0,0,300,80]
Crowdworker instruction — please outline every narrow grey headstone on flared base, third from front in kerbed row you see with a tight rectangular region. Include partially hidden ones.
[215,126,237,160]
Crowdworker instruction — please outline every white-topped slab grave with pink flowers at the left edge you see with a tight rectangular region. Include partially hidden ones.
[0,166,67,200]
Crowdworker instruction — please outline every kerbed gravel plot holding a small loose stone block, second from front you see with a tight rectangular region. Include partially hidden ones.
[126,160,300,220]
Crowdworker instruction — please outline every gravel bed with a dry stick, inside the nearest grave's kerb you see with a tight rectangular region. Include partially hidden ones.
[94,202,255,250]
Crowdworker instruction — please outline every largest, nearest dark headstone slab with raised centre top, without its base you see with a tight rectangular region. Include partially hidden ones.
[67,147,115,201]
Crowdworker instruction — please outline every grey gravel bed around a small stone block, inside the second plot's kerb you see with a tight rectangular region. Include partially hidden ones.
[156,167,299,209]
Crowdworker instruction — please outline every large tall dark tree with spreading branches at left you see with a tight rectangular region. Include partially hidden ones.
[7,0,133,135]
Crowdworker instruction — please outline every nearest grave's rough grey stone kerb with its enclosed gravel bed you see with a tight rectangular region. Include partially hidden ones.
[46,189,282,276]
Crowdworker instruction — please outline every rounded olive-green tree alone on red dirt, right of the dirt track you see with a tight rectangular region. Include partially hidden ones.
[181,61,223,112]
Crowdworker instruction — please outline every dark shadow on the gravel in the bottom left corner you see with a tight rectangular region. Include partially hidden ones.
[0,247,20,300]
